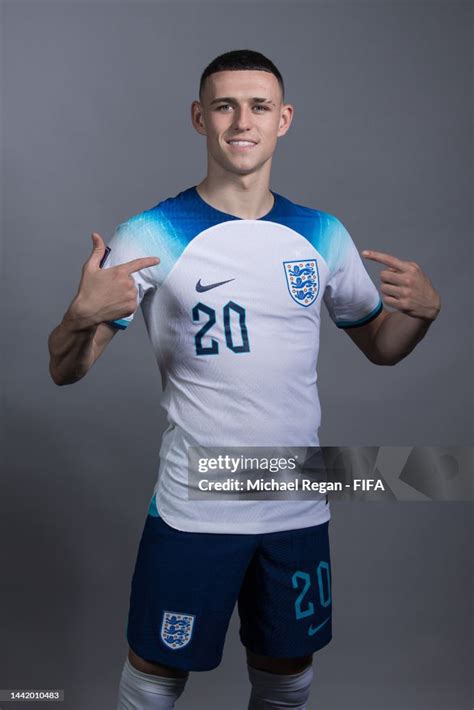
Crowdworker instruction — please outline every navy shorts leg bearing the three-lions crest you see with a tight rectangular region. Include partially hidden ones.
[127,515,254,671]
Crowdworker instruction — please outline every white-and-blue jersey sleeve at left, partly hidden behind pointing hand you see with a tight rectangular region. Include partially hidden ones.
[101,220,156,330]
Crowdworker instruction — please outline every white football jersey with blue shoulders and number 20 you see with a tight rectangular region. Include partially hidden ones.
[104,187,382,533]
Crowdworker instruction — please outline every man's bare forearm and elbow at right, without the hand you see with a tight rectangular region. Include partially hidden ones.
[374,311,433,365]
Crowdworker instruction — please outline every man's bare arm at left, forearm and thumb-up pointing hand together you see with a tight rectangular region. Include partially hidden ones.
[48,233,160,385]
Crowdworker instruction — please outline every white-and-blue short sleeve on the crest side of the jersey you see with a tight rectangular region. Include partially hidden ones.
[324,217,383,328]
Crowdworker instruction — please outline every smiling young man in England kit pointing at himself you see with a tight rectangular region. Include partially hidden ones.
[49,50,440,710]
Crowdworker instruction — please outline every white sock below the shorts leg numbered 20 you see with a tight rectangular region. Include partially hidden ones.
[247,664,313,710]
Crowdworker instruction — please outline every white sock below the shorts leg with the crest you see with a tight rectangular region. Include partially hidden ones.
[117,656,189,710]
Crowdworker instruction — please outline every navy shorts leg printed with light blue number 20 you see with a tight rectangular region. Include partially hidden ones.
[239,521,332,659]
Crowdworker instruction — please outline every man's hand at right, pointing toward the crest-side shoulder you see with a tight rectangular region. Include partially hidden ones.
[361,249,441,320]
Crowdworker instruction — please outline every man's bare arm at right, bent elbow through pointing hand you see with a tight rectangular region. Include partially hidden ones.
[346,250,441,365]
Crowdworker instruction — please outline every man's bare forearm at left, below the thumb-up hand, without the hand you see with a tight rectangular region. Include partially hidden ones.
[48,304,97,385]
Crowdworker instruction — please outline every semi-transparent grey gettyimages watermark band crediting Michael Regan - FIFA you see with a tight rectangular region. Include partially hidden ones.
[188,446,474,502]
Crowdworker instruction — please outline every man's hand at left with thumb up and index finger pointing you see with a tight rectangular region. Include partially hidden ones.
[68,232,160,328]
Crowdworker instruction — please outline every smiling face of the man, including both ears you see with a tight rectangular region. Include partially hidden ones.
[191,70,293,175]
